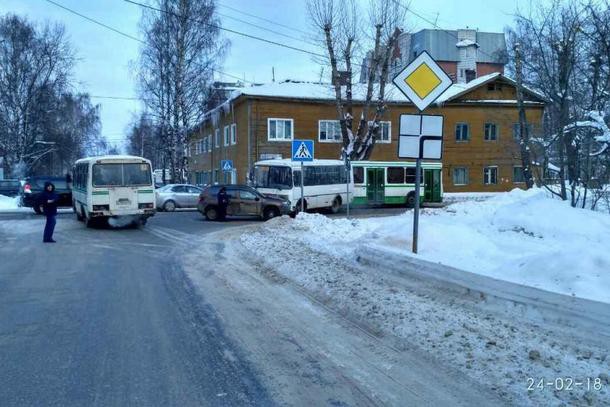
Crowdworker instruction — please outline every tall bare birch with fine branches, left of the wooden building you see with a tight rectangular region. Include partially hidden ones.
[138,0,227,181]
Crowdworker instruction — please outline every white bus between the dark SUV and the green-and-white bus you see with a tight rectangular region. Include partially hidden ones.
[251,159,354,213]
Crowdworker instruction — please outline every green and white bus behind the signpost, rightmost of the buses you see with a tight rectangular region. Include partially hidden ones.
[352,161,443,207]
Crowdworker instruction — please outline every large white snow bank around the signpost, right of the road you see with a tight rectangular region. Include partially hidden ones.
[251,189,610,303]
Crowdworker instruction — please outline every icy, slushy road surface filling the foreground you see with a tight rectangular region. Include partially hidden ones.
[0,212,607,406]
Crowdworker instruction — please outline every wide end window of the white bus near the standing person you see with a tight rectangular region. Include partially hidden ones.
[93,163,152,187]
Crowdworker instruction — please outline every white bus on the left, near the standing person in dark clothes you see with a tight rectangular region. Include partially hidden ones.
[72,155,155,227]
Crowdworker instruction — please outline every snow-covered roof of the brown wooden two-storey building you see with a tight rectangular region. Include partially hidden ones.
[206,72,544,118]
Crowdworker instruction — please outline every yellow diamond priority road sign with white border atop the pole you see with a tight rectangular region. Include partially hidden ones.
[393,51,452,110]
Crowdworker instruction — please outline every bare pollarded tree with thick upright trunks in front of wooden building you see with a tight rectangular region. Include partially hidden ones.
[307,0,407,160]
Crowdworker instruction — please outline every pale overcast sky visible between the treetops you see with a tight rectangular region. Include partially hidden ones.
[0,0,526,150]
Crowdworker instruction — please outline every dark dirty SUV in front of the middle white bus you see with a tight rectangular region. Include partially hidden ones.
[197,185,290,220]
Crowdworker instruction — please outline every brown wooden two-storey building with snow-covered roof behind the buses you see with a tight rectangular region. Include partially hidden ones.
[188,73,544,192]
